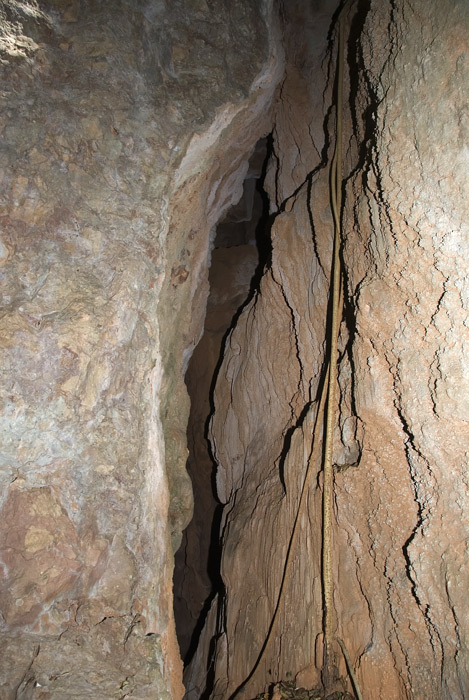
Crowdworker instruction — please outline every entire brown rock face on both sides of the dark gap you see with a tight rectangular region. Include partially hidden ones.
[0,0,469,700]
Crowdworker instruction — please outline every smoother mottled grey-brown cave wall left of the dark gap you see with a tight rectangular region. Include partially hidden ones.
[0,0,282,700]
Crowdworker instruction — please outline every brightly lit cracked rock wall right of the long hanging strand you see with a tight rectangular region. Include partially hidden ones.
[336,2,469,700]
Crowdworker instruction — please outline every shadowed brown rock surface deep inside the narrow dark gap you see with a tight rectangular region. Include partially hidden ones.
[174,245,258,658]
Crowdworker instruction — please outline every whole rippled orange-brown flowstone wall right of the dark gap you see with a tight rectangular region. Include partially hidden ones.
[190,0,469,700]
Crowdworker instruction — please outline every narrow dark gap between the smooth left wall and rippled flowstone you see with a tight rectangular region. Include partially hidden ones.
[174,136,272,666]
